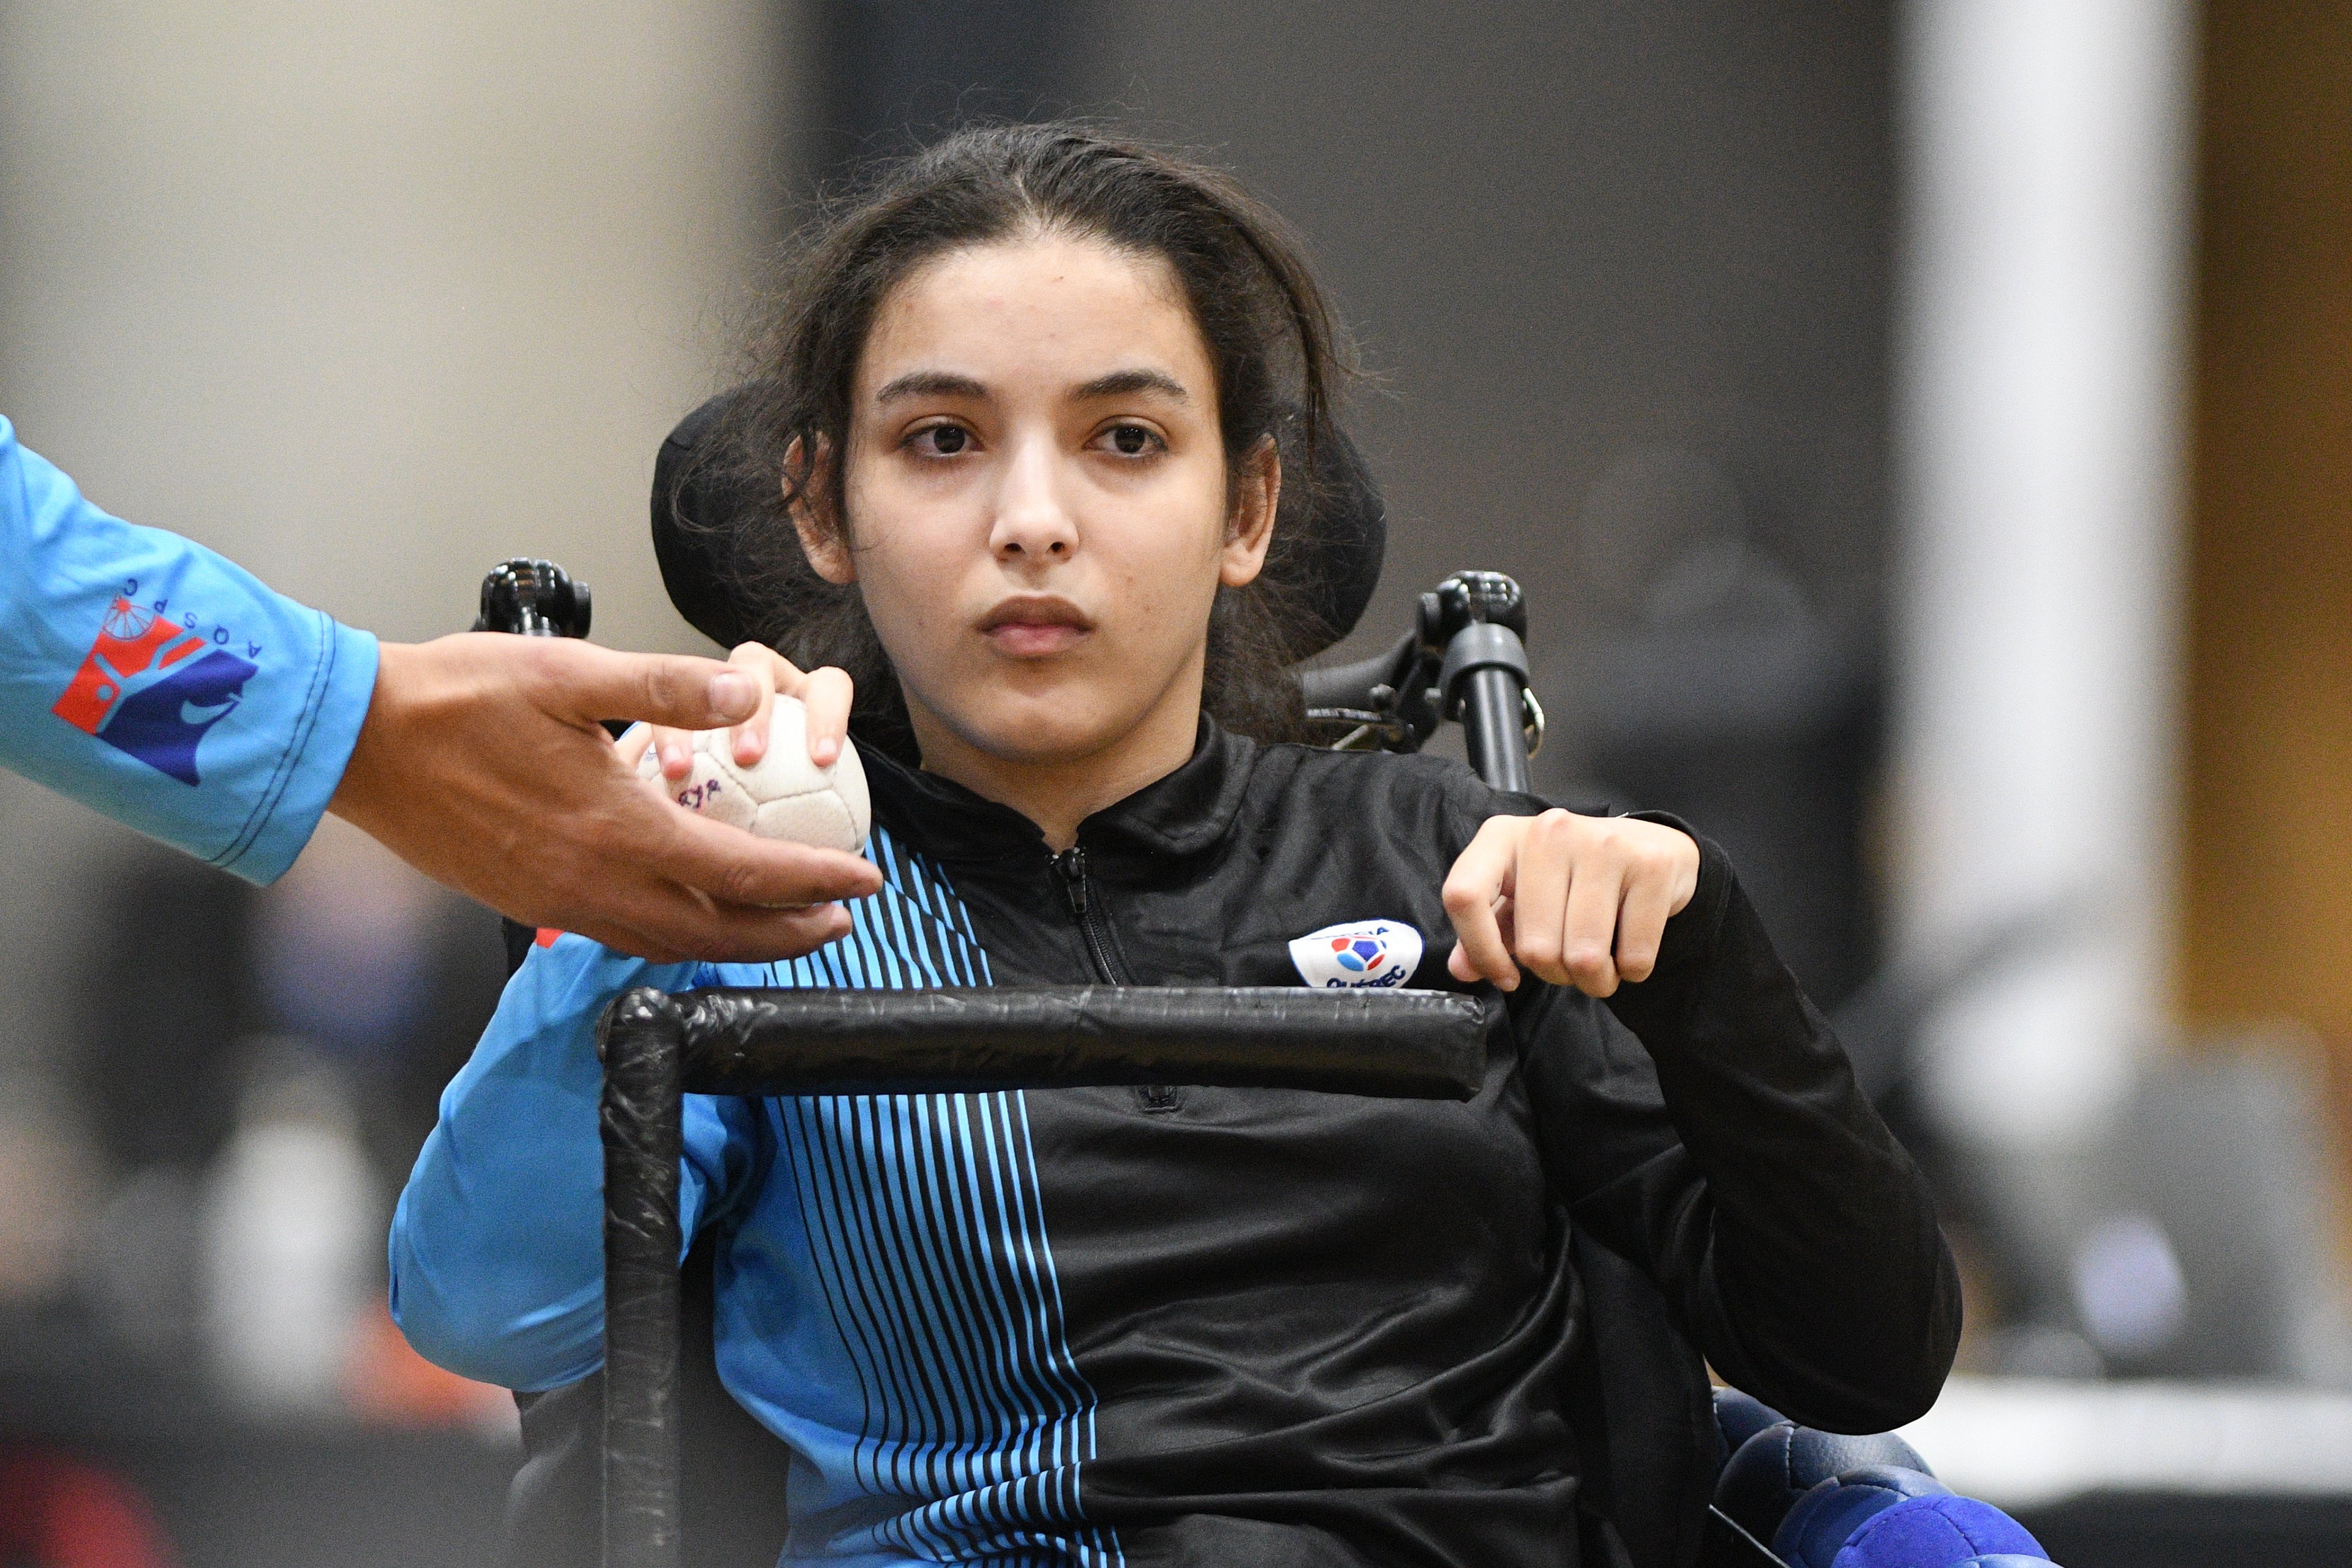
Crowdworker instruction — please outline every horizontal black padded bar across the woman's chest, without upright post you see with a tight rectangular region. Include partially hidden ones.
[675,985,1487,1100]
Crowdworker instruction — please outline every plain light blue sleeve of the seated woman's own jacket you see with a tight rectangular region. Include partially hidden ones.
[390,936,767,1392]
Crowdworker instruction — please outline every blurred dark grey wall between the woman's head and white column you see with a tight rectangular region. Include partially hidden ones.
[1072,0,1893,997]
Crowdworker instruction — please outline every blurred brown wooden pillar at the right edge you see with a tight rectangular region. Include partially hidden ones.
[2176,0,2352,1067]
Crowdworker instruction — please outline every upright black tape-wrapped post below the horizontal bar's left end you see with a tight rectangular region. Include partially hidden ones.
[597,987,684,1568]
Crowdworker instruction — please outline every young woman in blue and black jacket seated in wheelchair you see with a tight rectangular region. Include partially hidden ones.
[393,127,1959,1568]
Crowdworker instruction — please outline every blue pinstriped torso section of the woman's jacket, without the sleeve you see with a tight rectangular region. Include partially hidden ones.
[696,827,1125,1566]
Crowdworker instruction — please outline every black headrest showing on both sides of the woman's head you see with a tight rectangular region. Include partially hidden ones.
[654,393,1388,661]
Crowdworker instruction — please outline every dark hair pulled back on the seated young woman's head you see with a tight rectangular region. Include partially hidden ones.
[703,123,1345,760]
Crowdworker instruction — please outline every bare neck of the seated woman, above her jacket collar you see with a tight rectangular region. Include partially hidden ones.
[905,682,1199,853]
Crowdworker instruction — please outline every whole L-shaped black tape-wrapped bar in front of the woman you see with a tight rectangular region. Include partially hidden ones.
[597,985,1501,1568]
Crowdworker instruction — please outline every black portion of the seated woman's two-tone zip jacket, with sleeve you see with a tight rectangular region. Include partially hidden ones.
[505,724,1959,1568]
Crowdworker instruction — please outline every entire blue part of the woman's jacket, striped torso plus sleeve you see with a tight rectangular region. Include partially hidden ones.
[390,827,1125,1568]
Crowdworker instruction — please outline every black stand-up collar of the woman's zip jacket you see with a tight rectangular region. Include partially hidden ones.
[861,715,1261,861]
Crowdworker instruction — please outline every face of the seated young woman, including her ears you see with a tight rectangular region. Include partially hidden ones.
[802,235,1280,766]
